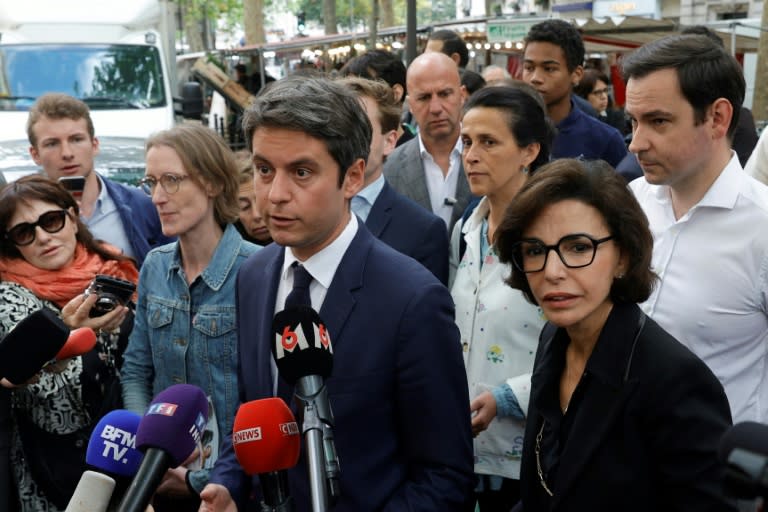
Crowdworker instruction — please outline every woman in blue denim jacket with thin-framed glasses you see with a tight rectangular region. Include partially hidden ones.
[123,124,258,512]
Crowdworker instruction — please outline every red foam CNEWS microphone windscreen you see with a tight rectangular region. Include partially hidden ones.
[232,398,301,475]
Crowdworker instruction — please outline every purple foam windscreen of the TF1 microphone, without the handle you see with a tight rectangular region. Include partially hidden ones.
[136,384,208,468]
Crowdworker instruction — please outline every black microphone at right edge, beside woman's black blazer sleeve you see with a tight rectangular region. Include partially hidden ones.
[718,421,768,499]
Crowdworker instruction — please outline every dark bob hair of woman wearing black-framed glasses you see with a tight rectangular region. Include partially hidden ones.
[494,159,657,304]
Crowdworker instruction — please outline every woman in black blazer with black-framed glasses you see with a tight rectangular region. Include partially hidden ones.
[495,159,735,512]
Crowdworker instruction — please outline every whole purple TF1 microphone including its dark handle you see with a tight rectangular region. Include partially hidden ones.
[117,384,208,512]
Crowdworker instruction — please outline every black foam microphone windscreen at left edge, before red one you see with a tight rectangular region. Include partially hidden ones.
[0,308,69,384]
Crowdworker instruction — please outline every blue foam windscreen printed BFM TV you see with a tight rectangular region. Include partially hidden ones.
[85,409,144,477]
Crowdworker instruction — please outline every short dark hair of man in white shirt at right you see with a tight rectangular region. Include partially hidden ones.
[621,34,746,140]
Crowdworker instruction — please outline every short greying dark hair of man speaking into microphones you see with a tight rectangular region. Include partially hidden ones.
[243,75,372,186]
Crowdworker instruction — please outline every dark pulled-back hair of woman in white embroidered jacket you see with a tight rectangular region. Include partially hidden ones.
[464,86,555,174]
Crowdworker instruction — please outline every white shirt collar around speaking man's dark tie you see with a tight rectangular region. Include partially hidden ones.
[278,215,358,311]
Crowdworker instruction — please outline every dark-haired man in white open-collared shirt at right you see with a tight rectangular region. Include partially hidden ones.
[622,35,768,422]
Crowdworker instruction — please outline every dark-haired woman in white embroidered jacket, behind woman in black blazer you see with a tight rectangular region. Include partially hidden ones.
[450,83,553,512]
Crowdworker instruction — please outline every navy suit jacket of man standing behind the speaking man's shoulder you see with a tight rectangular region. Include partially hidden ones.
[365,181,448,285]
